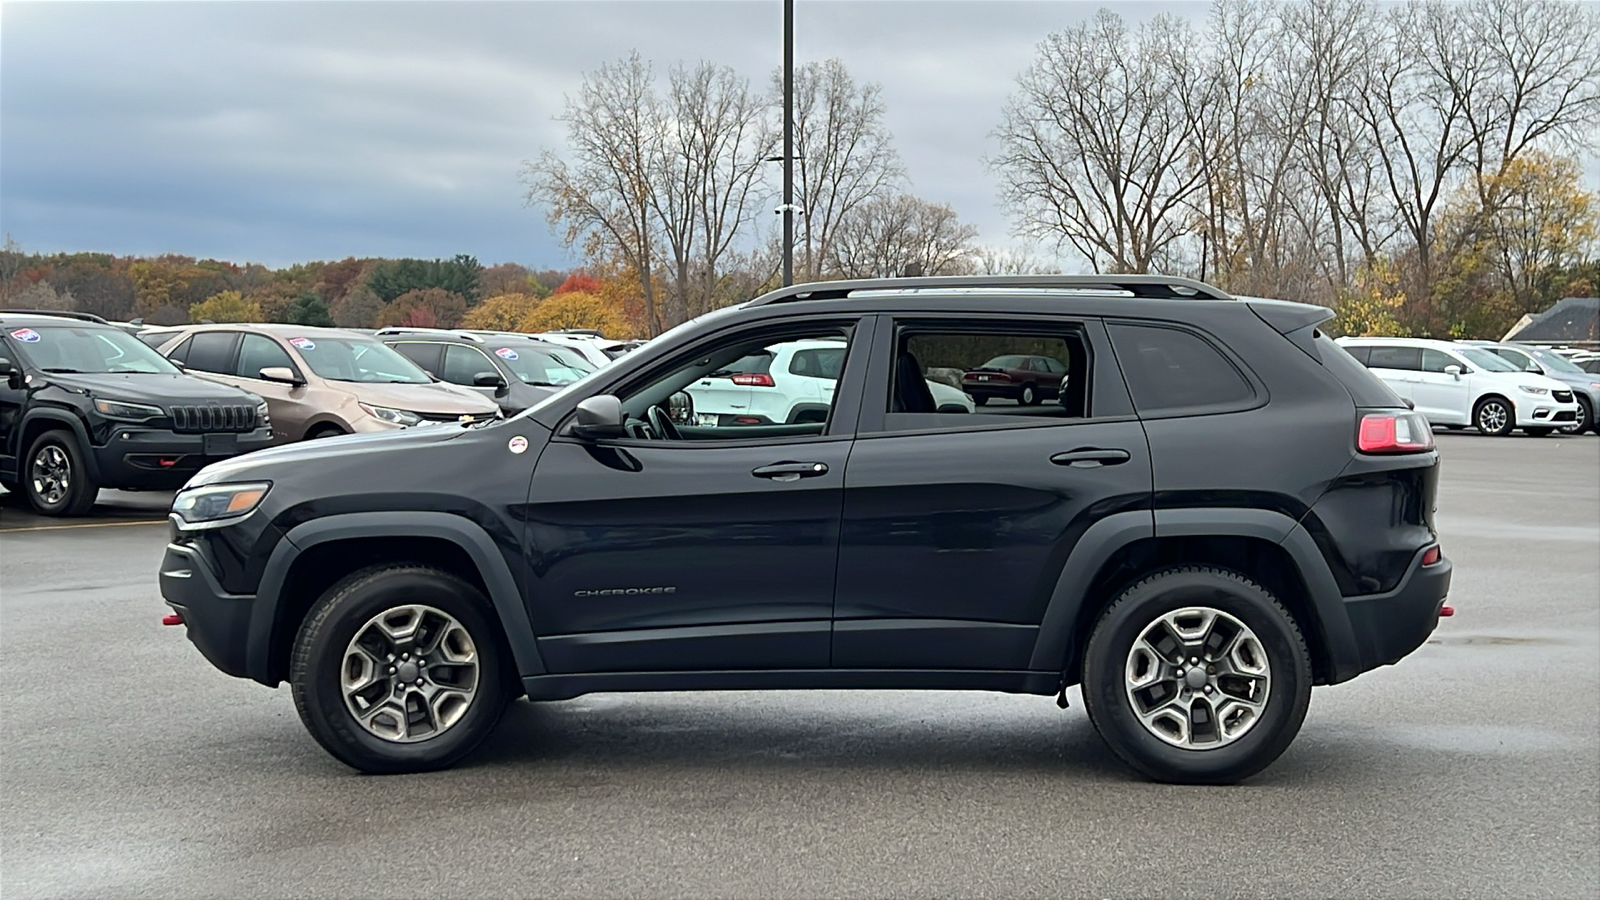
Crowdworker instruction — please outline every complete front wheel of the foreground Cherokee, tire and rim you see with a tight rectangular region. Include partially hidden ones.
[290,565,510,773]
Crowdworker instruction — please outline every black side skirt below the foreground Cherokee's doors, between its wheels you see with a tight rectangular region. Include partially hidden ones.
[522,669,1061,700]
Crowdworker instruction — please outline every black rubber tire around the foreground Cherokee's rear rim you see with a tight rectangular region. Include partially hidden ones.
[1082,567,1312,785]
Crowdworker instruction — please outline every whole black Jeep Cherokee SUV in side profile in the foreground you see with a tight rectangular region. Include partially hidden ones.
[160,275,1451,781]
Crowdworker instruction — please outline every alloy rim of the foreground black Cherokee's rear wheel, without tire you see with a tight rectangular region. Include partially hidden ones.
[1123,607,1272,749]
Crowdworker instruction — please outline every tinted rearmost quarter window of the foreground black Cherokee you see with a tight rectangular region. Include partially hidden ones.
[1107,323,1256,413]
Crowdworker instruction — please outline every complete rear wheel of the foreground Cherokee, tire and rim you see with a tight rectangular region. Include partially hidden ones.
[1083,569,1312,785]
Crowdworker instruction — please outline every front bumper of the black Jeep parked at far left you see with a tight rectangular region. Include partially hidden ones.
[93,428,272,490]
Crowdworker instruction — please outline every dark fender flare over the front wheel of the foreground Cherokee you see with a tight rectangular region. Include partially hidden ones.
[246,512,546,685]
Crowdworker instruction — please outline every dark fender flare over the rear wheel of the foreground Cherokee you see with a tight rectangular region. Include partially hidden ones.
[1029,508,1362,682]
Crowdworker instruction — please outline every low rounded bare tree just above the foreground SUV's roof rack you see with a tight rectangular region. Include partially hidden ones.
[826,194,978,279]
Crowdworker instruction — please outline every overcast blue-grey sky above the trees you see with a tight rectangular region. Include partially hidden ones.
[0,0,1206,267]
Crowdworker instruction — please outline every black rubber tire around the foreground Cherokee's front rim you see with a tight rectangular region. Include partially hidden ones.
[290,565,515,773]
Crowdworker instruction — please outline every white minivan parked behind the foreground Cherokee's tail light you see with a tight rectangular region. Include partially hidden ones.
[1339,338,1578,436]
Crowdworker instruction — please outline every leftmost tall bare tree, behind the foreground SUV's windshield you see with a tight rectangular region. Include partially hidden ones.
[523,51,666,333]
